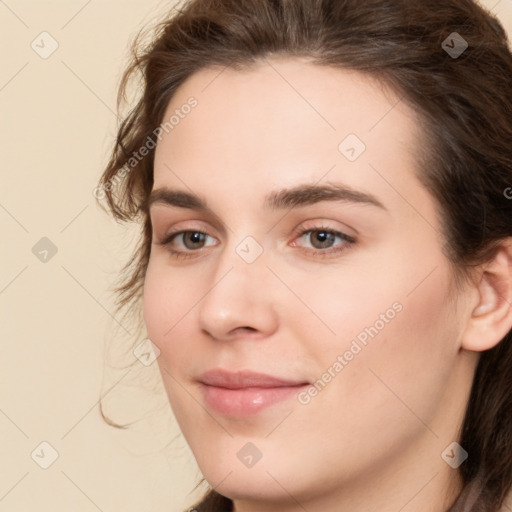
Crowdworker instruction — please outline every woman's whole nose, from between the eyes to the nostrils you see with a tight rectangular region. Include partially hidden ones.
[199,236,276,339]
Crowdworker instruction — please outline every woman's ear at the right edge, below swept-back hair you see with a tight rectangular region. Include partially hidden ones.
[461,238,512,352]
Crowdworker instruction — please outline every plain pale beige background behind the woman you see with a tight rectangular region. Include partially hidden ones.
[0,0,512,512]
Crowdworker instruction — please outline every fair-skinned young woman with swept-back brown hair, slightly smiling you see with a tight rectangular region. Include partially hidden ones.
[96,0,512,512]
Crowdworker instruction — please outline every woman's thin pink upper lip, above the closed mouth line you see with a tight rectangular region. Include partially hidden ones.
[198,368,308,389]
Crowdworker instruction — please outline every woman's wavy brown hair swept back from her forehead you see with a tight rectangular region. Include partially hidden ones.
[99,0,512,512]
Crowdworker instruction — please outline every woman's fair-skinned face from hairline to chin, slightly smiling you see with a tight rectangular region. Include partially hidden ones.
[144,59,474,510]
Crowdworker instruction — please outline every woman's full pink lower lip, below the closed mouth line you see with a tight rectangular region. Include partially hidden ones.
[202,384,309,417]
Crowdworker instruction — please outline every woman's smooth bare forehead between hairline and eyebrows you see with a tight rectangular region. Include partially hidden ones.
[154,58,428,216]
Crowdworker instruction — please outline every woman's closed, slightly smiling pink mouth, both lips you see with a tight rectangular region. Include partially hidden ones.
[198,369,310,417]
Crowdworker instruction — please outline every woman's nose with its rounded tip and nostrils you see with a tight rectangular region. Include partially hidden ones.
[198,243,278,340]
